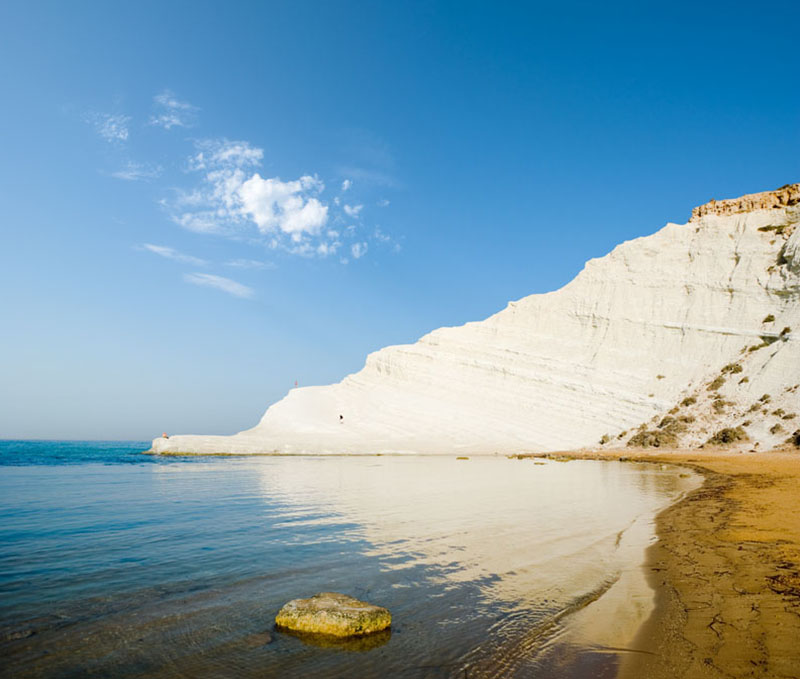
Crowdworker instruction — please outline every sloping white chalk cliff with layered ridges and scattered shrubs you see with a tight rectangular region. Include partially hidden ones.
[153,184,800,454]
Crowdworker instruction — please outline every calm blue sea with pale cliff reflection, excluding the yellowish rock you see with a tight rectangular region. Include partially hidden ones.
[0,441,696,677]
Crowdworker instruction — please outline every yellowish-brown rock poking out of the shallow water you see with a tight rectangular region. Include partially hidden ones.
[275,592,392,637]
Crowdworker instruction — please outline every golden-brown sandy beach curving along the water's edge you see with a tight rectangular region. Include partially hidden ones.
[552,450,800,679]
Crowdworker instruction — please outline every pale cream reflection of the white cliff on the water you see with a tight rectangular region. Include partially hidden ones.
[259,457,692,608]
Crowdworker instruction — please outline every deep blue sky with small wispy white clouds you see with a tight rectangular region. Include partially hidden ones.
[0,0,800,440]
